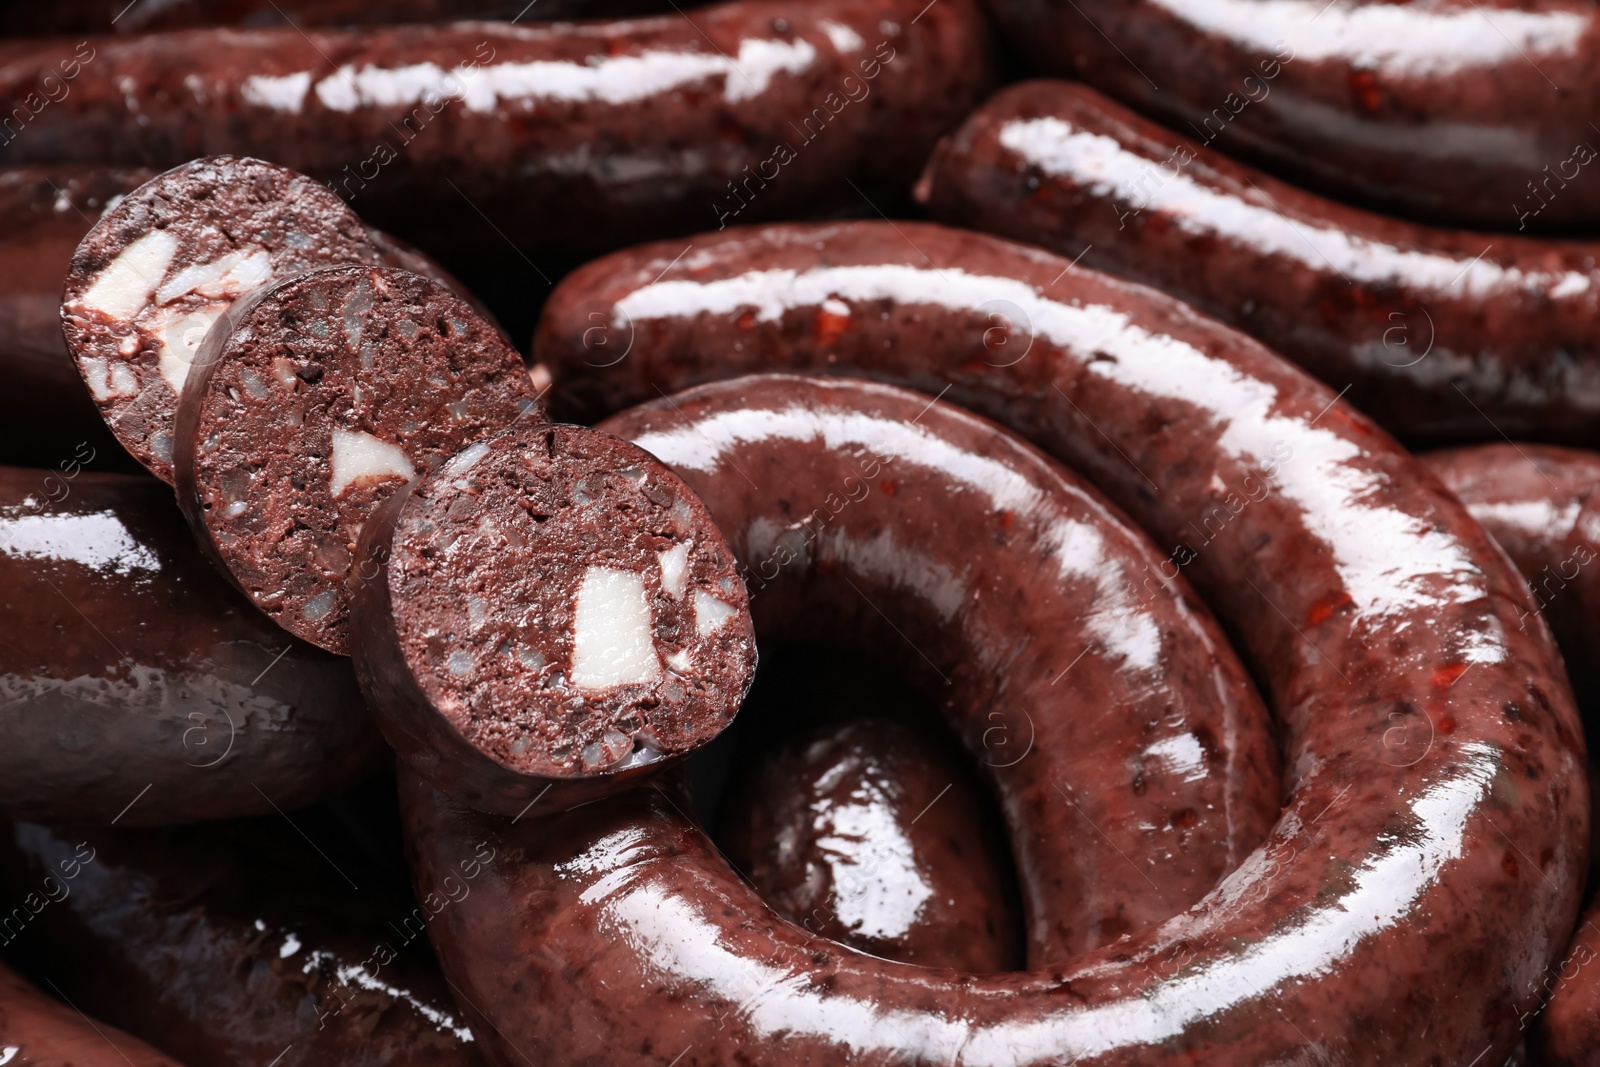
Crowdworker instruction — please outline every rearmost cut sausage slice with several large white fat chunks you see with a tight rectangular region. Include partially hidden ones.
[61,157,390,482]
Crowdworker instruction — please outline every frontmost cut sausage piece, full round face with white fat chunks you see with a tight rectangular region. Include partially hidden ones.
[352,426,755,814]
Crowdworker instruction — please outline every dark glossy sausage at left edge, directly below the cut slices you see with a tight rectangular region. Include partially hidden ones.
[0,458,384,825]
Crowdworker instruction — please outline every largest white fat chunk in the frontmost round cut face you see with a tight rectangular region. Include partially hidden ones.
[573,566,661,689]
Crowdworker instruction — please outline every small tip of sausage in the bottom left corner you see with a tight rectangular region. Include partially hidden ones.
[0,963,182,1067]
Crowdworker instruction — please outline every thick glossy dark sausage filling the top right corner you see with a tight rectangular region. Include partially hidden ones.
[990,0,1600,230]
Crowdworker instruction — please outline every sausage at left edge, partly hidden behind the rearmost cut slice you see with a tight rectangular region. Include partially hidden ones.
[0,166,150,469]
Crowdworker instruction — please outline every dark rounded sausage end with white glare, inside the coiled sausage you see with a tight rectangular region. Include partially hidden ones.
[717,718,1021,974]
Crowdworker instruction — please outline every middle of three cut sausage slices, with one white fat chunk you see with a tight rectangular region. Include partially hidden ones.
[174,266,538,654]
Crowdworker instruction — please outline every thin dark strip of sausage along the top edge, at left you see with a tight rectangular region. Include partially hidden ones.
[0,0,678,37]
